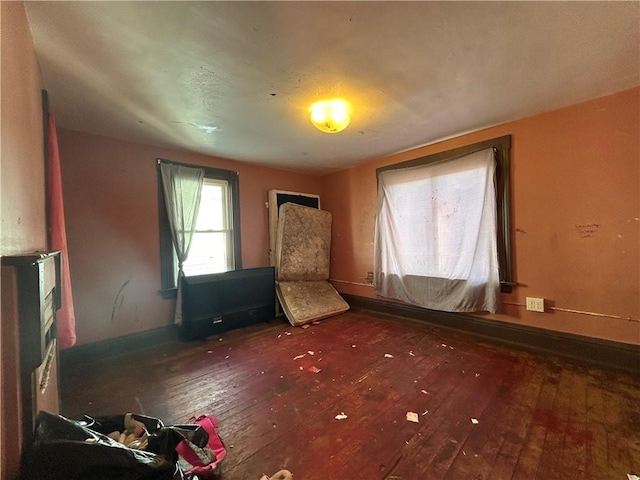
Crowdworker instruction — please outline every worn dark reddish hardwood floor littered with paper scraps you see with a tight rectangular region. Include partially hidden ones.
[61,312,640,480]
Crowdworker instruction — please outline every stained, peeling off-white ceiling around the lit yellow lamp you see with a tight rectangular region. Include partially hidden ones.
[25,1,640,173]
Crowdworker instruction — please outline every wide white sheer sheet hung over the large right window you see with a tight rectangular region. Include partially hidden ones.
[374,148,500,312]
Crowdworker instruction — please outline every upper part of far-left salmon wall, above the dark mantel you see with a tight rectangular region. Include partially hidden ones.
[0,2,47,255]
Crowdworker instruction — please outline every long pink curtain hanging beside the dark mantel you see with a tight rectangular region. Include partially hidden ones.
[46,113,76,348]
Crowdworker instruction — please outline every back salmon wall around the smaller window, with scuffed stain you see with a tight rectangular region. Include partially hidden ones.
[58,129,320,344]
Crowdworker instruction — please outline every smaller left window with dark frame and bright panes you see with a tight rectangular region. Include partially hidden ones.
[158,159,242,298]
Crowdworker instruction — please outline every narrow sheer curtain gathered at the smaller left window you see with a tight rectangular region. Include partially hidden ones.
[160,162,204,324]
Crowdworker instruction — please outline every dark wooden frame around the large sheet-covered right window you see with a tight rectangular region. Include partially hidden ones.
[376,135,516,293]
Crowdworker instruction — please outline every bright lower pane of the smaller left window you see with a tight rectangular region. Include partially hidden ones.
[183,232,230,276]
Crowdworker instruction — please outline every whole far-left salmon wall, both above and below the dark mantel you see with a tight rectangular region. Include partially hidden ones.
[0,2,47,480]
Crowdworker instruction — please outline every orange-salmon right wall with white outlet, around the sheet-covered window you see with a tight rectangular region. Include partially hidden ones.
[322,88,640,345]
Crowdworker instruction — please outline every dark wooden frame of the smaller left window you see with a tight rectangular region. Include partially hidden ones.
[156,158,242,298]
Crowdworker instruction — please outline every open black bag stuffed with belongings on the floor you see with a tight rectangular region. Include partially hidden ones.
[20,412,209,480]
